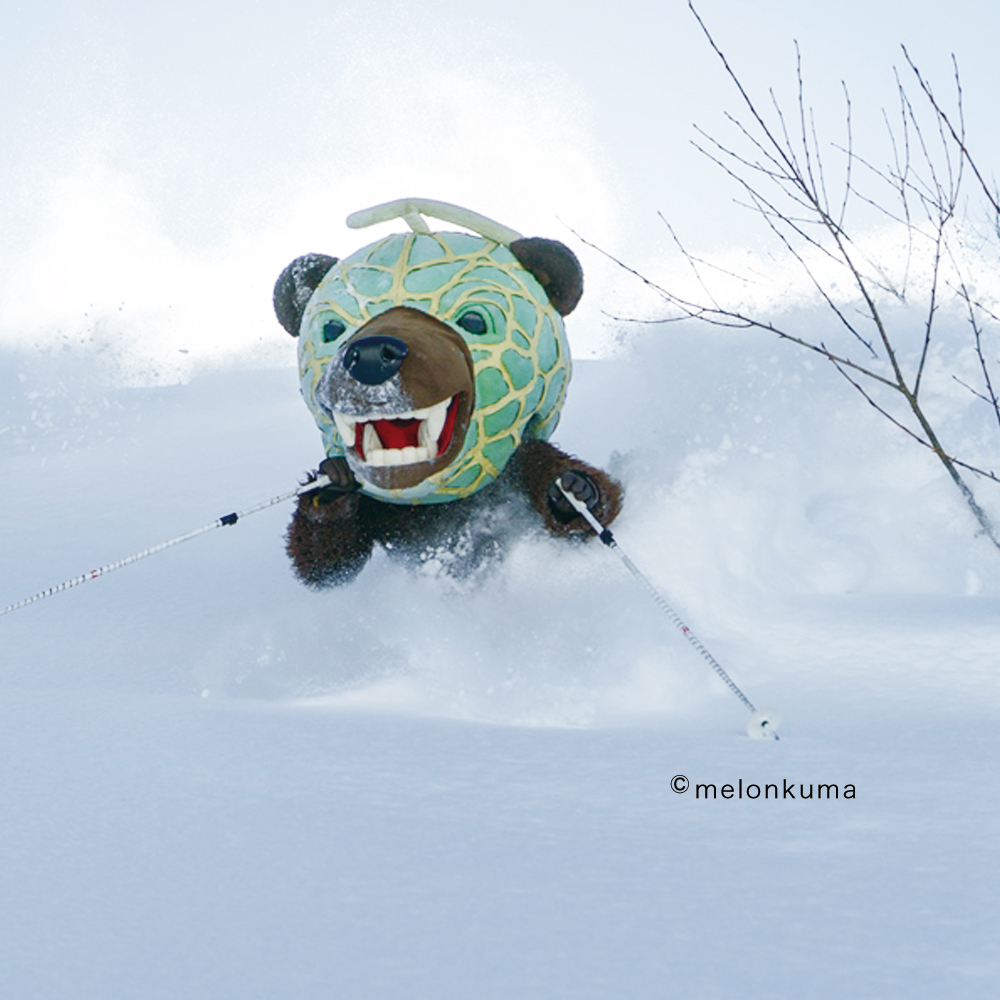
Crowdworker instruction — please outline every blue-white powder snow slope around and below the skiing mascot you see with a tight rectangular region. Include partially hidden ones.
[0,324,1000,1000]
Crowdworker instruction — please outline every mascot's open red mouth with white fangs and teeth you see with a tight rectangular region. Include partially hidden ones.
[333,393,460,466]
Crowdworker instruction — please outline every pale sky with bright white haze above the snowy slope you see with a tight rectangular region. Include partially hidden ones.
[0,0,1000,368]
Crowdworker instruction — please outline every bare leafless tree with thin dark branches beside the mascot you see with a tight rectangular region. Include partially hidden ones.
[596,0,1000,549]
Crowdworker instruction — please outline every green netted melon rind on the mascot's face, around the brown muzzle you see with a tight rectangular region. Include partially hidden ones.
[299,233,571,503]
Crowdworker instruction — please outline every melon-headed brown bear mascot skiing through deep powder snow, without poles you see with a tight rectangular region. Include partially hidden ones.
[274,199,622,587]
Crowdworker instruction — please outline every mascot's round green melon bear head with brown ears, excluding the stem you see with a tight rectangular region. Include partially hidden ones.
[275,220,582,503]
